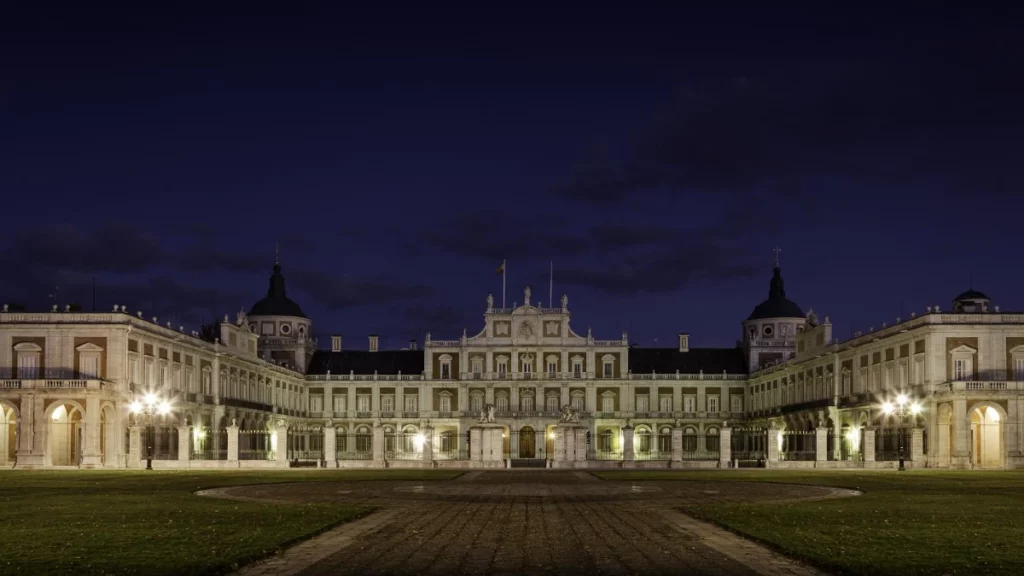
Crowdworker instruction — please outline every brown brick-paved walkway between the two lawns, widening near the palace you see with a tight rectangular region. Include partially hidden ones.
[199,470,856,576]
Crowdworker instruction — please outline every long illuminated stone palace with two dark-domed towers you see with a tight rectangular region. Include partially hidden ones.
[0,255,1024,468]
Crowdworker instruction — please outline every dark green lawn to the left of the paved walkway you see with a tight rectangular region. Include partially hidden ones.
[0,470,459,575]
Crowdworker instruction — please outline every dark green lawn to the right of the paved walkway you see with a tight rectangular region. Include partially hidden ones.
[597,470,1024,576]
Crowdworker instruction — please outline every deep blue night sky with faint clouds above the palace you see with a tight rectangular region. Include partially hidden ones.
[0,3,1024,347]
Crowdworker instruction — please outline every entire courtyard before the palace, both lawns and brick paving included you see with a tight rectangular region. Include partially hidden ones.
[0,470,1024,576]
